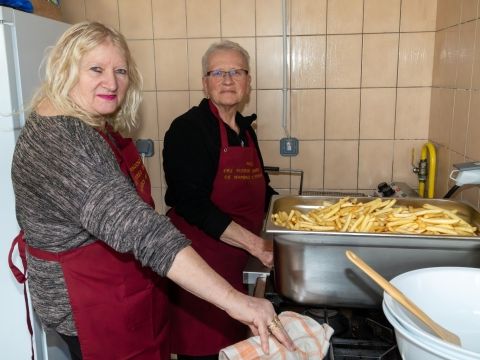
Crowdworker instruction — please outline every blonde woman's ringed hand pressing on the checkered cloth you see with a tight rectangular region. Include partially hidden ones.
[225,288,295,355]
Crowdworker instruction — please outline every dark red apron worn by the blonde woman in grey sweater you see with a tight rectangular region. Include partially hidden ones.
[8,126,170,360]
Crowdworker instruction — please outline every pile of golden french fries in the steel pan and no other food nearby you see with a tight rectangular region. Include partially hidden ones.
[272,197,477,236]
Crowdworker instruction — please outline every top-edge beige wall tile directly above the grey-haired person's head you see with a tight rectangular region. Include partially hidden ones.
[220,0,255,37]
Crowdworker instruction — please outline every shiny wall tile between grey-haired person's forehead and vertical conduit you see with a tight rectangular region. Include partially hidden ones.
[257,37,283,89]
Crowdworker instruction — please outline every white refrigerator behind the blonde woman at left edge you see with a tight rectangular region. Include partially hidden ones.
[0,6,69,360]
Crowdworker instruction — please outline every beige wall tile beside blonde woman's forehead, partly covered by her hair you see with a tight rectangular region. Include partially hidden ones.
[128,40,156,91]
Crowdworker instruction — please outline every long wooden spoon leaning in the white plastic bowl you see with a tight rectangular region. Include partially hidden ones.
[345,250,462,346]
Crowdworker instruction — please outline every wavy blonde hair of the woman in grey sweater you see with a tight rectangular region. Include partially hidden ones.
[30,22,143,130]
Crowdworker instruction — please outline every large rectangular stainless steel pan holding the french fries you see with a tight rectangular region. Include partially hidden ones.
[265,195,480,308]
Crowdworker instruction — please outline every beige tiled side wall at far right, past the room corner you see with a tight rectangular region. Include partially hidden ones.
[429,0,480,208]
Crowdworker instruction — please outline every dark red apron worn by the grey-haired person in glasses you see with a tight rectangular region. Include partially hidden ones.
[167,109,265,356]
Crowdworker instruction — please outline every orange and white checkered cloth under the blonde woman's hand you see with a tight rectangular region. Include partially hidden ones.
[219,311,333,360]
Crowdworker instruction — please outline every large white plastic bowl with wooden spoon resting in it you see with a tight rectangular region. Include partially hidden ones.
[383,267,480,360]
